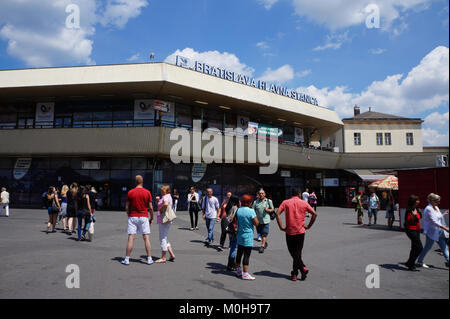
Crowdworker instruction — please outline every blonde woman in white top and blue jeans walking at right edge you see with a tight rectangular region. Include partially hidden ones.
[418,193,448,268]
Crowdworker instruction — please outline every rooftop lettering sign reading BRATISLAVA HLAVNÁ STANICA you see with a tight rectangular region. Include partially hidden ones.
[176,55,319,105]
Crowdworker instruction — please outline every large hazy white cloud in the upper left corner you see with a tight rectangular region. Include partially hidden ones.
[0,0,146,67]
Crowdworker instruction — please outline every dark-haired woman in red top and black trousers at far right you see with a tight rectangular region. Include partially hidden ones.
[405,195,423,271]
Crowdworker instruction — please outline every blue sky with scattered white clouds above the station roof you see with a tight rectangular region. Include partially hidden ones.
[0,0,449,146]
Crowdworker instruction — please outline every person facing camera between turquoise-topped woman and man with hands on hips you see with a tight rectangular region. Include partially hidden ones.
[252,188,275,254]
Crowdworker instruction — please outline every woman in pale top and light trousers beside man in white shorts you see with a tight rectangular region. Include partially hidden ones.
[155,185,175,264]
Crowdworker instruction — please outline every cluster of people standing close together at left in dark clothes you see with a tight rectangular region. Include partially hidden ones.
[43,183,97,241]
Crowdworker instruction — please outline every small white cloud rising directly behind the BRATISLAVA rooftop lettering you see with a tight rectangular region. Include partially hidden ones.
[165,48,255,76]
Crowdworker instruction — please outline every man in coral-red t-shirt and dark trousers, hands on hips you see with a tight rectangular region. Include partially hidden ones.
[277,188,317,281]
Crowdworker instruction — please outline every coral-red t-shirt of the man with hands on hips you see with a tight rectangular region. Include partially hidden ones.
[278,196,314,235]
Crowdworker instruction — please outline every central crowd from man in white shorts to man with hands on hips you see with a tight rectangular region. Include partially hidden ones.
[121,175,317,281]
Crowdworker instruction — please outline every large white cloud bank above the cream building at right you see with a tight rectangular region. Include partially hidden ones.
[299,46,449,117]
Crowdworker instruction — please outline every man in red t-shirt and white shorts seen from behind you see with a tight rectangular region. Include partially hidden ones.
[122,175,153,265]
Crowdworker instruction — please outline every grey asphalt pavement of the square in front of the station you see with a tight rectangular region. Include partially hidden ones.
[0,207,449,299]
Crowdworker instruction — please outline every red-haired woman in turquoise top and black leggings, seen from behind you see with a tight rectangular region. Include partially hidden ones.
[236,194,258,280]
